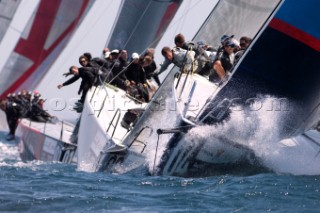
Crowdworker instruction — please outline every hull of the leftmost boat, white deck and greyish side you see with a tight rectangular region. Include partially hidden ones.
[16,119,77,164]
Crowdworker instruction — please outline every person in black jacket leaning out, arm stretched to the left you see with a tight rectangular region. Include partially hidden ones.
[58,66,95,104]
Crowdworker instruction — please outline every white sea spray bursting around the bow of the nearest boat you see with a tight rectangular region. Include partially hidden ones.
[149,96,294,174]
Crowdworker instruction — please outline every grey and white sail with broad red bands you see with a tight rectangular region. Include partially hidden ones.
[0,0,94,97]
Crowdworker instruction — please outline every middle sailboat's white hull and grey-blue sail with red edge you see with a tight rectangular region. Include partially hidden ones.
[78,0,188,171]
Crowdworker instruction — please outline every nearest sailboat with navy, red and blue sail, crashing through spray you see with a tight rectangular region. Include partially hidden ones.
[84,0,320,176]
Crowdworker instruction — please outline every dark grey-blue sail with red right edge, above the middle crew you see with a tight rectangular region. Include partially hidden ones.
[106,0,182,53]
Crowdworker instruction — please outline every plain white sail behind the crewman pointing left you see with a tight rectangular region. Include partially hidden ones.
[37,0,121,122]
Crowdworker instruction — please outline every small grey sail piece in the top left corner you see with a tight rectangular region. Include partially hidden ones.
[0,0,21,43]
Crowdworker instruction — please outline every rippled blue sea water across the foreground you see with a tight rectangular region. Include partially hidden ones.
[0,138,320,213]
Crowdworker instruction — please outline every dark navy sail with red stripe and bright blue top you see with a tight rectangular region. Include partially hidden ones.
[200,0,320,138]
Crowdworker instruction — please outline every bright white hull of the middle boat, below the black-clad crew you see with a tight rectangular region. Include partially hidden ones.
[78,85,146,172]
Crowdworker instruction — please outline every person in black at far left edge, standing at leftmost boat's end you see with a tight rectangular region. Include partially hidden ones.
[0,99,22,141]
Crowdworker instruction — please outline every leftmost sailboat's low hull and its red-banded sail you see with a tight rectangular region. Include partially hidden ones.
[0,0,94,163]
